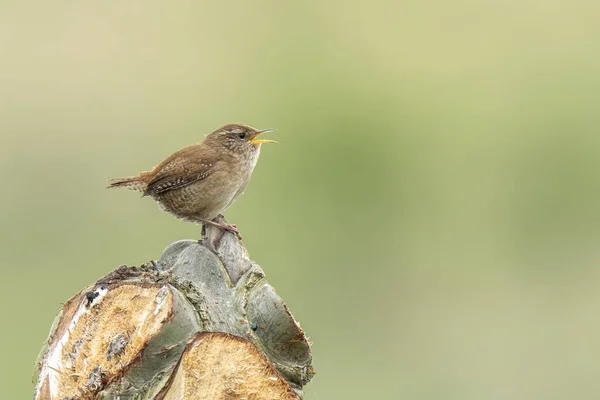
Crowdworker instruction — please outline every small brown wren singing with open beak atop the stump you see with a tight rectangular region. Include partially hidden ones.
[108,124,274,239]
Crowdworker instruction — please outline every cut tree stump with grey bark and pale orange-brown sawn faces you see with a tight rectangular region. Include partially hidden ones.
[34,228,314,400]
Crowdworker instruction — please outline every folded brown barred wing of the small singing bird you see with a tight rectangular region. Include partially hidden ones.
[144,144,217,196]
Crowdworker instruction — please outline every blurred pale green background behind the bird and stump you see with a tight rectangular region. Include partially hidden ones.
[0,0,600,400]
